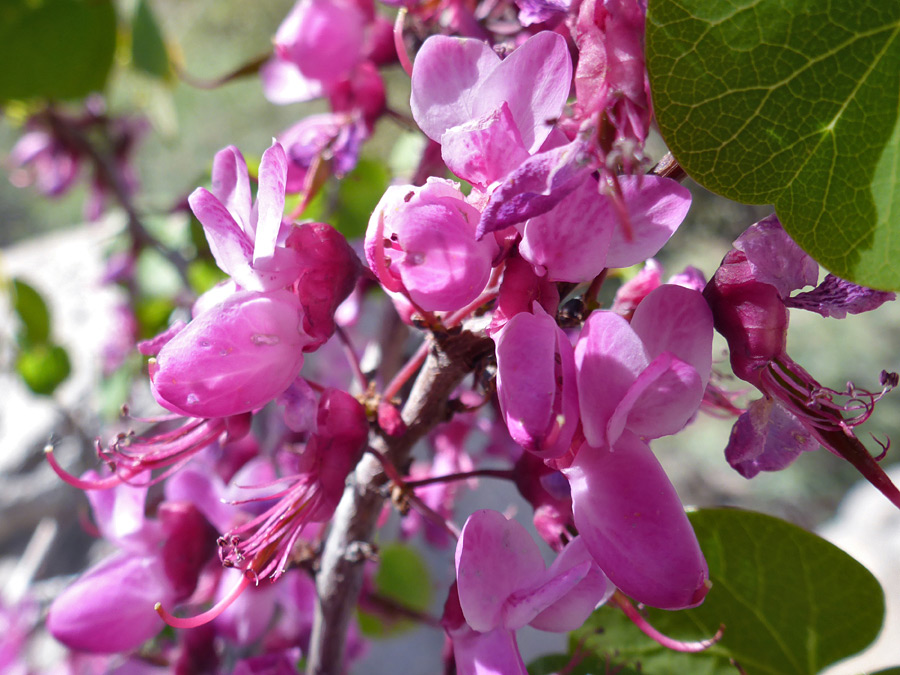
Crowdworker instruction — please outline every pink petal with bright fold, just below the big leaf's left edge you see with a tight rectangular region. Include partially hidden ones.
[606,175,691,267]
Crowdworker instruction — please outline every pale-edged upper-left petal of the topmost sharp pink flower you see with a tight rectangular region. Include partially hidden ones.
[410,35,502,142]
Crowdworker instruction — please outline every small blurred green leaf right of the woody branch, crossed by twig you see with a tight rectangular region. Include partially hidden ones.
[360,544,432,637]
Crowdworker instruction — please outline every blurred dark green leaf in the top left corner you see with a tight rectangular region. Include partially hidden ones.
[0,0,116,102]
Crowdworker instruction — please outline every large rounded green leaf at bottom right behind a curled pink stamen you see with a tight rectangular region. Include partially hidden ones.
[572,509,884,675]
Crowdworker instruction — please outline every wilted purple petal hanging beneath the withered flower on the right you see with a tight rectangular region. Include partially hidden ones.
[725,398,819,478]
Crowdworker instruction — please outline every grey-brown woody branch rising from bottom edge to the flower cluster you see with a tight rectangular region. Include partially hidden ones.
[306,330,493,675]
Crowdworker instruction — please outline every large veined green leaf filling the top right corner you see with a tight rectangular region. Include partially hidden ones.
[647,0,900,290]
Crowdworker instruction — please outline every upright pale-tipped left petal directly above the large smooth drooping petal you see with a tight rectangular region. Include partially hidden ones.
[575,312,649,446]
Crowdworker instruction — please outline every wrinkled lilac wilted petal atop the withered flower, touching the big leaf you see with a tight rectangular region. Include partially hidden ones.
[734,214,819,298]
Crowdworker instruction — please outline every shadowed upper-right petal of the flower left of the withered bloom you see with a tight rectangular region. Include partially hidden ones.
[631,284,713,388]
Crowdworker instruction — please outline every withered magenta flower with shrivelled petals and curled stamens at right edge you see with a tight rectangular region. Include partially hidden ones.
[704,216,900,506]
